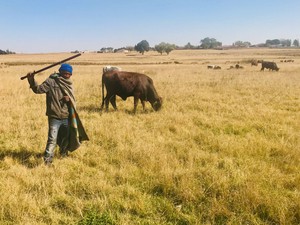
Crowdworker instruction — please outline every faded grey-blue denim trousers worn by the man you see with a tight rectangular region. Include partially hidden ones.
[44,117,69,163]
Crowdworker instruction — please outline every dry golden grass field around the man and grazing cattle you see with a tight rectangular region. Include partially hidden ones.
[0,49,300,225]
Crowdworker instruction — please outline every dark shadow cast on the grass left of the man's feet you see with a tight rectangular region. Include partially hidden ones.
[0,149,43,169]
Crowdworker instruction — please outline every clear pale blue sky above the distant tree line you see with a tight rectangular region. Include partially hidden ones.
[0,0,300,53]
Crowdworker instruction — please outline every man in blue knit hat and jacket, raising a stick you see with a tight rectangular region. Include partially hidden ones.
[27,64,75,165]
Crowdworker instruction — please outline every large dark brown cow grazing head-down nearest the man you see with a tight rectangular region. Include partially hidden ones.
[101,70,162,113]
